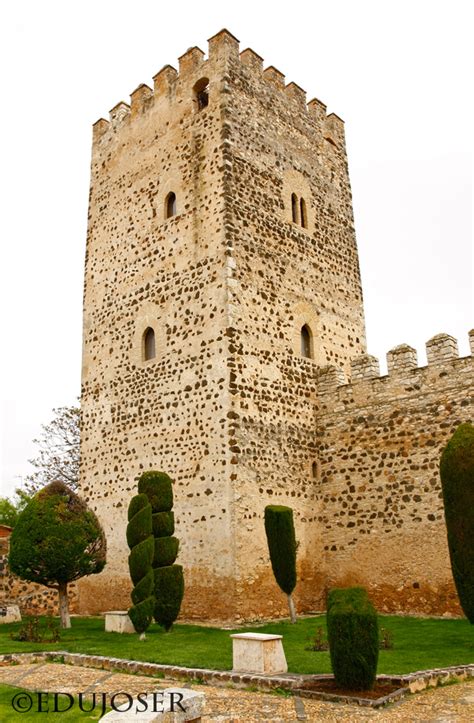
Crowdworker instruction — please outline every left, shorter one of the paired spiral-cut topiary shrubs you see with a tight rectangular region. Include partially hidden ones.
[127,494,155,635]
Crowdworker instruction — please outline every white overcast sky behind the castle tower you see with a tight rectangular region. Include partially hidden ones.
[0,0,474,495]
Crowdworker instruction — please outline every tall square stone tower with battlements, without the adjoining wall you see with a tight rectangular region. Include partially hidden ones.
[79,30,365,620]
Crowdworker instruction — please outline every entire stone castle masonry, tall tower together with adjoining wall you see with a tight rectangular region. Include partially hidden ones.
[78,30,474,621]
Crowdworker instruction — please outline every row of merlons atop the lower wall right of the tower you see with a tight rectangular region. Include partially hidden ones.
[318,329,474,395]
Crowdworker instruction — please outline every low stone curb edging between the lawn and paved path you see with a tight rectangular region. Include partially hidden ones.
[0,650,474,708]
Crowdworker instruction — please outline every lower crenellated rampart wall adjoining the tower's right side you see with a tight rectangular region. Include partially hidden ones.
[315,332,474,615]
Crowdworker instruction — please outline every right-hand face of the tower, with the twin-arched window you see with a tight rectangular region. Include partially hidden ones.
[206,36,365,618]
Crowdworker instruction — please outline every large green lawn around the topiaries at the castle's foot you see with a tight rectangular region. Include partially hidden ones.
[0,615,474,674]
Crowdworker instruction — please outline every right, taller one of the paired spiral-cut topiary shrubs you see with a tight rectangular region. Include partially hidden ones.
[138,471,184,631]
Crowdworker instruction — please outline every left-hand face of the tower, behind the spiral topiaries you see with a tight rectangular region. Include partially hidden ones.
[80,31,243,617]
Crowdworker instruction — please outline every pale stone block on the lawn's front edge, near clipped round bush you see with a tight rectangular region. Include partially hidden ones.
[230,633,288,675]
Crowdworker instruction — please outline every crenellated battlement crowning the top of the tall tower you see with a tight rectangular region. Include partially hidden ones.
[93,29,344,148]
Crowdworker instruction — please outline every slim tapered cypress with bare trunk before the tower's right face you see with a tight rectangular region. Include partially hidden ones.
[265,505,297,623]
